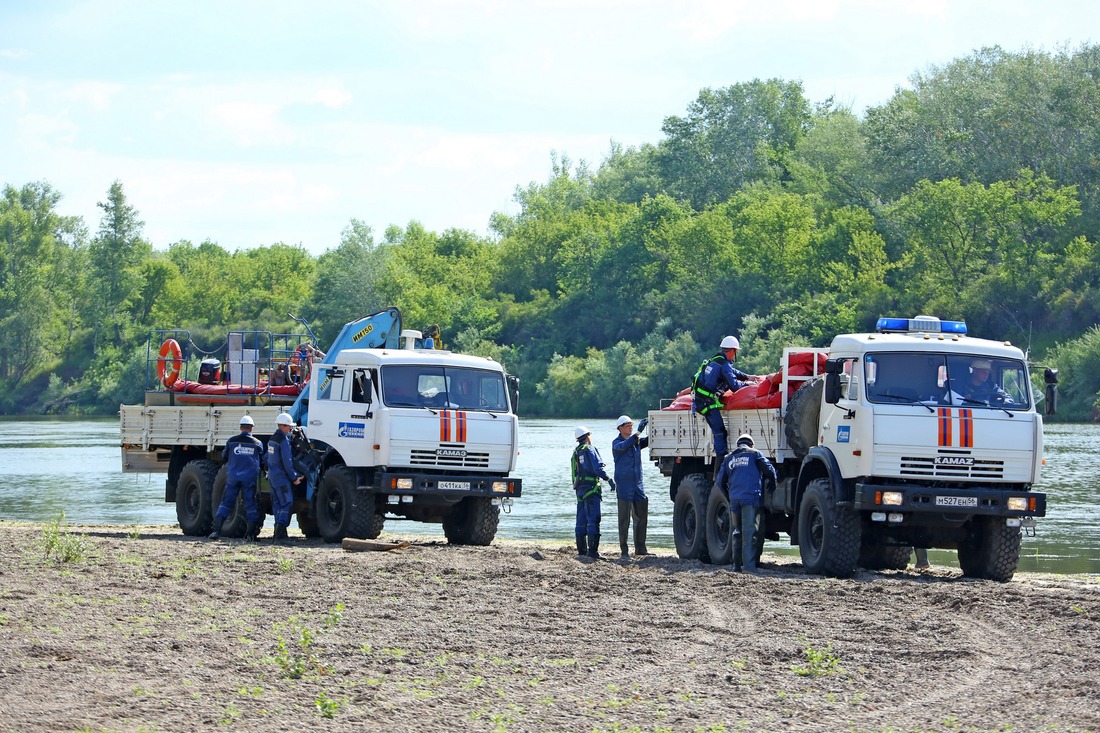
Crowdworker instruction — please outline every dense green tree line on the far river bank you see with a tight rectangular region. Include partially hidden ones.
[0,46,1100,419]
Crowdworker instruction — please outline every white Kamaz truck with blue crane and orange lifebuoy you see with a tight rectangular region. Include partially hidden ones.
[119,309,521,545]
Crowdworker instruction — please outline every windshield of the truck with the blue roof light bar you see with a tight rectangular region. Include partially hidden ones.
[864,352,1031,409]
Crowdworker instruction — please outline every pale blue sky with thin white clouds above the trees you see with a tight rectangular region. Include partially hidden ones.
[0,0,1100,254]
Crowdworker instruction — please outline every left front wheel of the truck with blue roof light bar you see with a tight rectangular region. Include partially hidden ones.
[799,479,861,578]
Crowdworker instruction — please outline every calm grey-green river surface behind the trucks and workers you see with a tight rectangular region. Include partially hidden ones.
[0,418,1100,575]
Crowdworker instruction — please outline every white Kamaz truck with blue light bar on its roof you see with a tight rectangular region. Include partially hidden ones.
[649,316,1057,581]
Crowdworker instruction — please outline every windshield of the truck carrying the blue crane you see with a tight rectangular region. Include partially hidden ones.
[382,364,508,413]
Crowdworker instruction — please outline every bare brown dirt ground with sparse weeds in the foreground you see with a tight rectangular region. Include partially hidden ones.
[0,523,1100,733]
